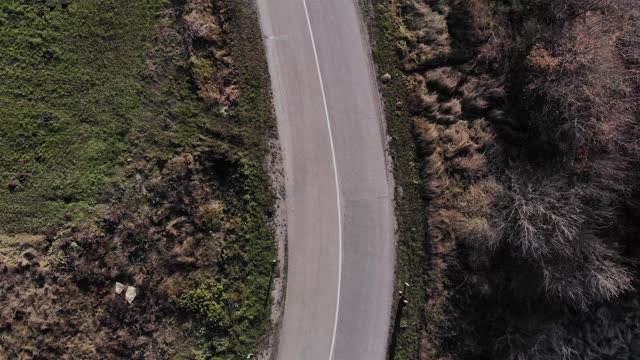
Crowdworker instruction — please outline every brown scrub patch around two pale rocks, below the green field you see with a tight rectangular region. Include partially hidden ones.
[0,148,233,359]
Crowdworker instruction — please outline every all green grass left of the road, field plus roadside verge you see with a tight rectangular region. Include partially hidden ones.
[0,0,275,359]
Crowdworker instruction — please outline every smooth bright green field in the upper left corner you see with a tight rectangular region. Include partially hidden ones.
[0,1,168,232]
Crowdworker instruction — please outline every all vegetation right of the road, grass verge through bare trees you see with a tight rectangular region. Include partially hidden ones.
[364,0,640,359]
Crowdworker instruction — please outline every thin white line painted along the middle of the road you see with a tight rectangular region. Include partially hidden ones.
[302,0,342,360]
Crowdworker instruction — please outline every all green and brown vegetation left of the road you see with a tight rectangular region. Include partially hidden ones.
[0,0,275,359]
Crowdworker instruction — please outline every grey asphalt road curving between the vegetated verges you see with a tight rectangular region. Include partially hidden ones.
[257,0,395,360]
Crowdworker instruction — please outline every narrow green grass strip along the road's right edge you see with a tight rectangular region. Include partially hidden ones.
[366,0,431,360]
